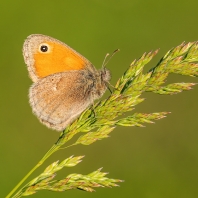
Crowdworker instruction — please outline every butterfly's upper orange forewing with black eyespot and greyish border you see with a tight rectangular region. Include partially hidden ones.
[23,34,96,82]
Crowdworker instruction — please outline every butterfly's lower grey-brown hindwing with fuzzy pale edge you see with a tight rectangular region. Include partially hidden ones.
[29,70,93,131]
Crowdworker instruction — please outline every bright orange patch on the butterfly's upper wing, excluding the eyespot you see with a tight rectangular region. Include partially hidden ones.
[34,41,87,78]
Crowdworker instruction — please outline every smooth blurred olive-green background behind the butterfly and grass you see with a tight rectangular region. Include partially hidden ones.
[0,0,198,198]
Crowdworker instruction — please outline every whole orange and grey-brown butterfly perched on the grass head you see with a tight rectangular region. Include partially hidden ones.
[23,35,110,131]
